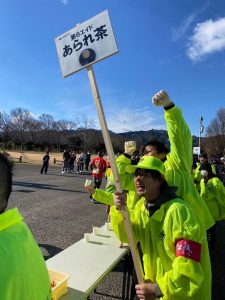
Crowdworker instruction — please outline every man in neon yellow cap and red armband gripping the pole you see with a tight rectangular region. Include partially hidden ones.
[111,156,211,300]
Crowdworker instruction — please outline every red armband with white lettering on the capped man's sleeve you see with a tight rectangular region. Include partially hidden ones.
[176,239,202,262]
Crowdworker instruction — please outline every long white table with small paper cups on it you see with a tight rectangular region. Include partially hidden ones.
[46,226,129,300]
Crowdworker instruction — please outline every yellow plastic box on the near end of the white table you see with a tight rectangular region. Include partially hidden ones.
[48,269,69,300]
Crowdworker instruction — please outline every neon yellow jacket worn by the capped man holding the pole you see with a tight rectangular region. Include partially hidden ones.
[111,198,211,300]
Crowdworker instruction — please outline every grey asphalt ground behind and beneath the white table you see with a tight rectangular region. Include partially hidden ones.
[9,164,225,300]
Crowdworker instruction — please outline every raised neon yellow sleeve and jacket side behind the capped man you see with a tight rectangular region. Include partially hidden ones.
[164,106,215,229]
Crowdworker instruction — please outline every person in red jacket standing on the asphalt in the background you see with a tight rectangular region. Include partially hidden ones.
[90,151,106,202]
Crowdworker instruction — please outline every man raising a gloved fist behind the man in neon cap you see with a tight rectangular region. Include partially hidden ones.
[95,91,215,230]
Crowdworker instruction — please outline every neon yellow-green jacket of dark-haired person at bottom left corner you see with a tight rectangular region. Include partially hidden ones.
[0,208,51,300]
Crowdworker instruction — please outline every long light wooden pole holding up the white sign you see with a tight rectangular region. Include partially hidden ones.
[87,65,144,284]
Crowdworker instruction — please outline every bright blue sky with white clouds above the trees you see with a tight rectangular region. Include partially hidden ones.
[0,0,225,135]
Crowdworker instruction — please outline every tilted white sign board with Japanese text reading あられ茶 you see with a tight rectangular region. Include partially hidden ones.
[55,10,118,77]
